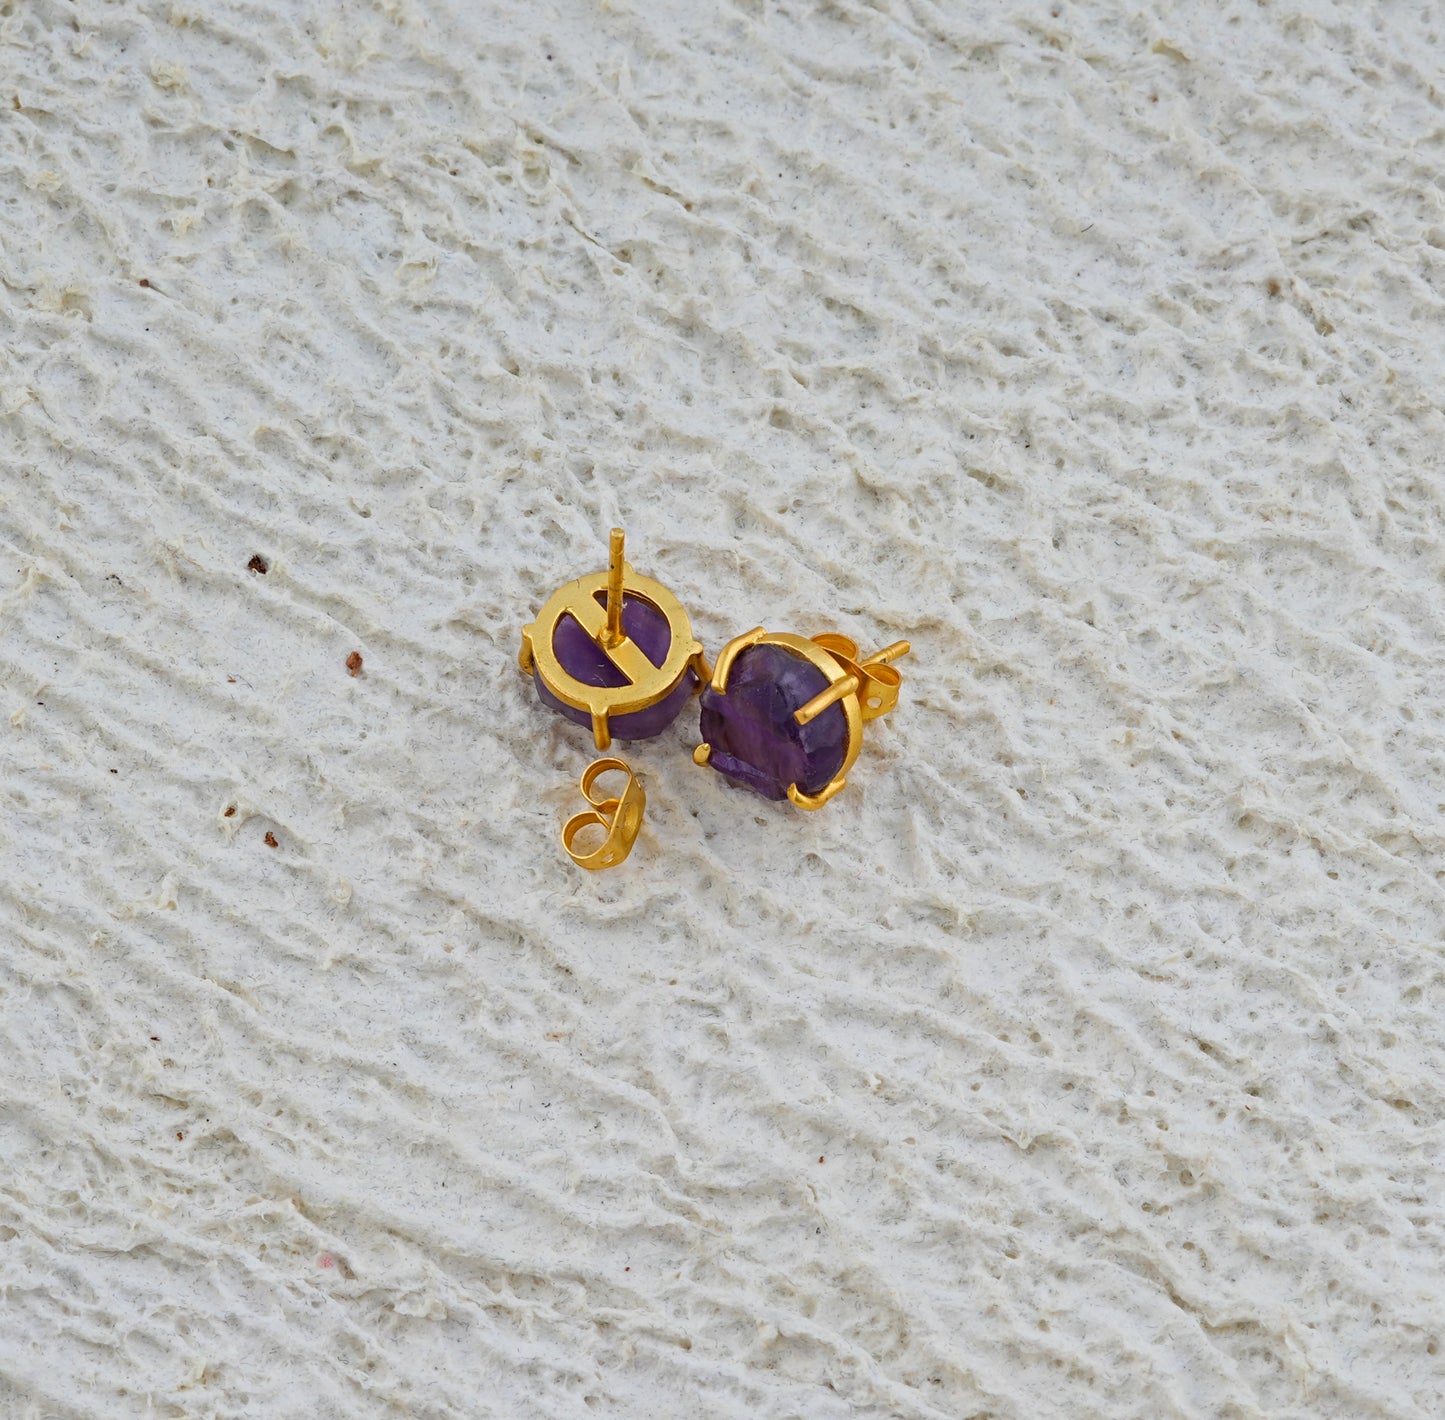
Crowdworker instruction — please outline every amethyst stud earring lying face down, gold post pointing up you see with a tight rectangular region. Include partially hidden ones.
[517,527,708,750]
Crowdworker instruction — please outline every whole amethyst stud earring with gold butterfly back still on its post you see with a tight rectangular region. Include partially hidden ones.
[692,627,909,809]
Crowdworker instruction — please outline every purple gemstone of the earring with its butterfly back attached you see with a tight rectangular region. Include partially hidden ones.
[698,641,848,799]
